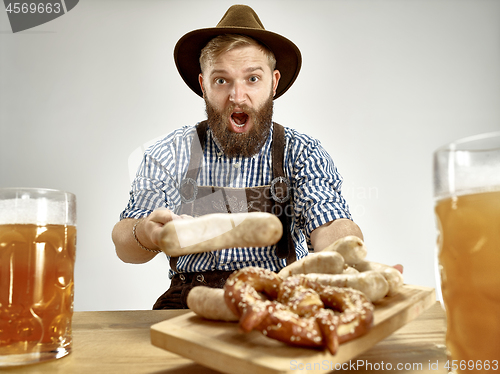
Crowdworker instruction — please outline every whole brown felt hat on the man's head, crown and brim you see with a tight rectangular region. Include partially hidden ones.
[174,5,302,99]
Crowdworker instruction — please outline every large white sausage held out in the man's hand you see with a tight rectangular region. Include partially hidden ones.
[159,212,283,257]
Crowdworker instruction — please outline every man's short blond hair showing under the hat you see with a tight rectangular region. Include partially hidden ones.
[200,34,276,72]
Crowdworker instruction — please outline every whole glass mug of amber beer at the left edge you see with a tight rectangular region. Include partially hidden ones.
[0,188,76,369]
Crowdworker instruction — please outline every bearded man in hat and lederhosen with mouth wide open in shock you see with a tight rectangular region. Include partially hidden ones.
[113,5,362,309]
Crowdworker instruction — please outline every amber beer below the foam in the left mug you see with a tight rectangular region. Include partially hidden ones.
[0,224,76,355]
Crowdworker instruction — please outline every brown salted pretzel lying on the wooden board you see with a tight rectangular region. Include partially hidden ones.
[224,267,373,354]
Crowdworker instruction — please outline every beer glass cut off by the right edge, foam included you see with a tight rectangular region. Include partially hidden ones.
[434,132,500,373]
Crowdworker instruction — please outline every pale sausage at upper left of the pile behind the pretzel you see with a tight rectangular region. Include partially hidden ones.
[278,252,344,279]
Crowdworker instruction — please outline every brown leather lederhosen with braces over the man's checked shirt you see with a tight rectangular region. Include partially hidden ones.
[153,121,296,309]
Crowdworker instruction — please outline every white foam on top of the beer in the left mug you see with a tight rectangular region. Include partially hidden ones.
[0,198,76,225]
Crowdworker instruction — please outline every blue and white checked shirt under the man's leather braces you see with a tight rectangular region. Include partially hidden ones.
[120,122,351,276]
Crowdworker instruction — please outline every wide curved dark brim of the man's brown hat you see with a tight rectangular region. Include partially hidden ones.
[174,27,302,99]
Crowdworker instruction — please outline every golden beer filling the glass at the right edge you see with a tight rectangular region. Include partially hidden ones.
[435,190,500,372]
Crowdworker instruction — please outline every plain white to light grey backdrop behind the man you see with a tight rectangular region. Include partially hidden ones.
[0,0,500,310]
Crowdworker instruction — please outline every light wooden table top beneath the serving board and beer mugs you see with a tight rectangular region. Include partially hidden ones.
[0,303,447,374]
